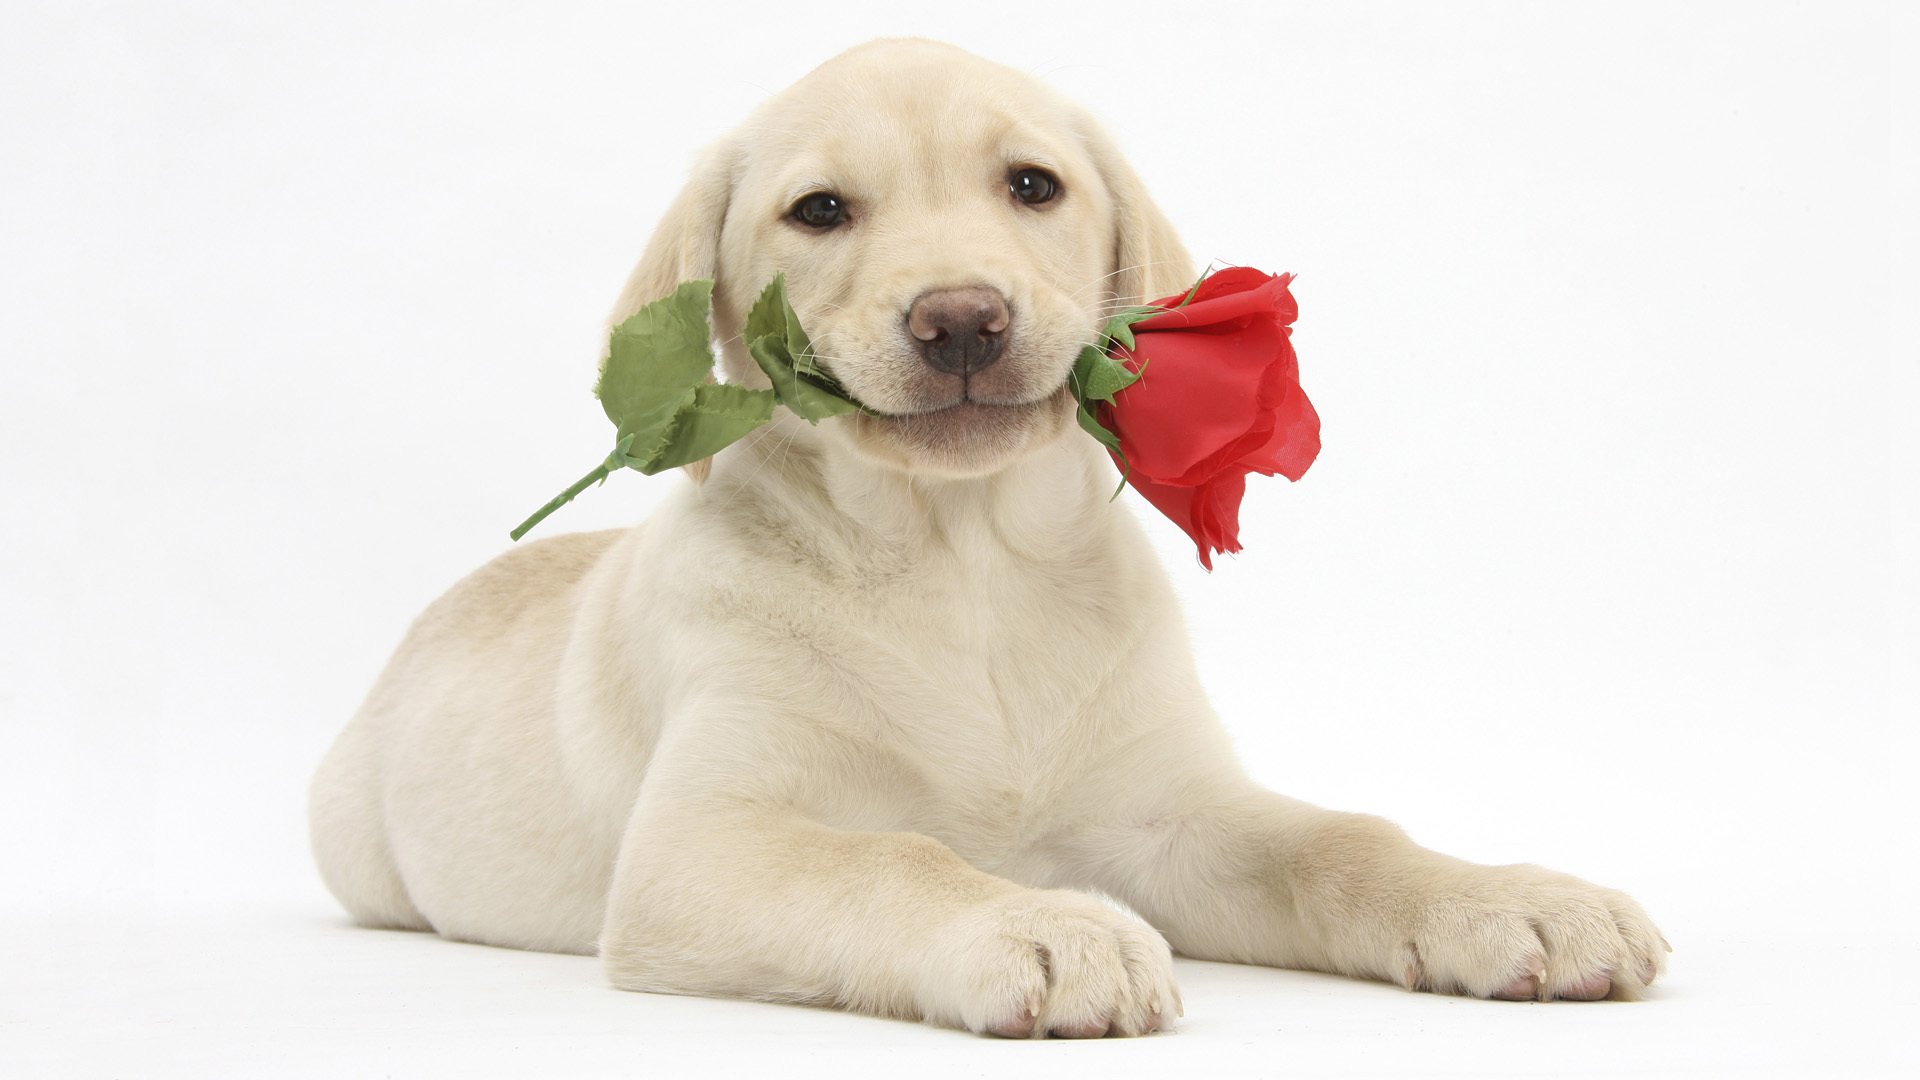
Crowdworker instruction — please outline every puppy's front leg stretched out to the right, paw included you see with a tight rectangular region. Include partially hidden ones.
[1069,778,1667,999]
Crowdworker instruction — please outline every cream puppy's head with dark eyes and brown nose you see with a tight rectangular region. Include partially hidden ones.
[612,40,1192,475]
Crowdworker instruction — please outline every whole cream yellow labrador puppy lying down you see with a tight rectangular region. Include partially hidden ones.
[313,40,1663,1036]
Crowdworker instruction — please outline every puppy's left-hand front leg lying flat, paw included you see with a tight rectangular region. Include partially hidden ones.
[601,798,1179,1038]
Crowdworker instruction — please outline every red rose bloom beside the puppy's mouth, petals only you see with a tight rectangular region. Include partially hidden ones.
[1098,267,1319,569]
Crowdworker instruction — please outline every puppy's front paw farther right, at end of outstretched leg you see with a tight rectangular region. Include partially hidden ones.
[1402,867,1670,1001]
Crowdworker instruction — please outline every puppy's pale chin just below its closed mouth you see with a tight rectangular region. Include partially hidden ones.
[854,386,1073,477]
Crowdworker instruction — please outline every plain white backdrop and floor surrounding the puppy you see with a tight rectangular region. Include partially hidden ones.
[0,0,1920,1076]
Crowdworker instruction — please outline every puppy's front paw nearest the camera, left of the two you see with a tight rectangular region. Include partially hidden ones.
[920,890,1181,1038]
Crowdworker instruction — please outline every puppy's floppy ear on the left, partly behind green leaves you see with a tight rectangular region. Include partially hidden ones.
[599,142,739,482]
